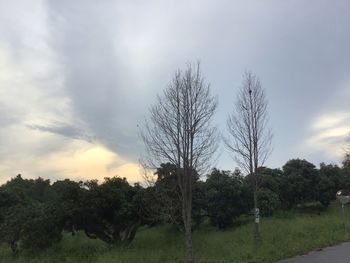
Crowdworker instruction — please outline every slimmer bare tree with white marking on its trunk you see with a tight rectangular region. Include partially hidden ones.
[224,72,272,241]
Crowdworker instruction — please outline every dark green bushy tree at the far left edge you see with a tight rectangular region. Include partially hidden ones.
[0,175,61,253]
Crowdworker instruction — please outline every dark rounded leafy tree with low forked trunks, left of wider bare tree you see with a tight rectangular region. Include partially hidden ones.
[69,177,141,244]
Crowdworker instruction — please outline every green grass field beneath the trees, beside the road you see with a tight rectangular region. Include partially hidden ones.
[0,204,350,263]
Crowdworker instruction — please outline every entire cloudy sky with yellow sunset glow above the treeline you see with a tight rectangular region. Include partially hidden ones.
[0,0,350,186]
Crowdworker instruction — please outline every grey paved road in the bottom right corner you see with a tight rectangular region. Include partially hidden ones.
[278,242,350,263]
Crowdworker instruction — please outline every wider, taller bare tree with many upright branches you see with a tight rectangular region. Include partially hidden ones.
[141,63,217,262]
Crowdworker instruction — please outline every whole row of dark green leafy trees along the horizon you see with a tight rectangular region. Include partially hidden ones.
[0,159,350,253]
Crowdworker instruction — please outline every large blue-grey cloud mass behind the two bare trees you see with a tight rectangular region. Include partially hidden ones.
[43,0,350,168]
